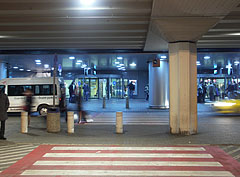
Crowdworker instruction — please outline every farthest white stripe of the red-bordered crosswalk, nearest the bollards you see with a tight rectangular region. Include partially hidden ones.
[51,146,206,151]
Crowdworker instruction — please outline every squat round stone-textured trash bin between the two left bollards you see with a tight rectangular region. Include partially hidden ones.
[47,108,61,133]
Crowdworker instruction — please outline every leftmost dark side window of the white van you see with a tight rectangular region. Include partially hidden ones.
[8,85,33,96]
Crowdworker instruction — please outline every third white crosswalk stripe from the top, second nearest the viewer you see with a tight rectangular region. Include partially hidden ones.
[33,161,222,167]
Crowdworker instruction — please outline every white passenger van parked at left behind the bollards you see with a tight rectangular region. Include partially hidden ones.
[0,77,66,115]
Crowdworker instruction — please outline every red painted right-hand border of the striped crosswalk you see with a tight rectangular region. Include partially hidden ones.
[205,146,240,177]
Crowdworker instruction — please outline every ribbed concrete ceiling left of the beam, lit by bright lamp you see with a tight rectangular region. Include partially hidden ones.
[0,0,152,50]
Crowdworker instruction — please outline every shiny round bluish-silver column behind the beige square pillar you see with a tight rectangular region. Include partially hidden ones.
[149,60,169,108]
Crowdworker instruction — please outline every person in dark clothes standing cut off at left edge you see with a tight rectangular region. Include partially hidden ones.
[0,89,9,140]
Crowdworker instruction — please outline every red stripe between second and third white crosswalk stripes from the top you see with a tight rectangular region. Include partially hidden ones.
[39,157,217,162]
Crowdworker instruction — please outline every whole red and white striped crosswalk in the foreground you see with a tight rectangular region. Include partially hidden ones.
[0,145,240,177]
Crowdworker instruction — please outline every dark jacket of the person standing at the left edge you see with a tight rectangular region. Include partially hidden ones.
[0,92,9,121]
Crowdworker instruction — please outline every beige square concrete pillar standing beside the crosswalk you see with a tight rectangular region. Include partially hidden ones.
[169,42,197,135]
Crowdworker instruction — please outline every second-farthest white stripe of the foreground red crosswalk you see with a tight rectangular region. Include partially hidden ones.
[43,153,213,158]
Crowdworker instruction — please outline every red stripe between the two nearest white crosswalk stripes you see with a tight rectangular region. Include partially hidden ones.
[29,165,225,171]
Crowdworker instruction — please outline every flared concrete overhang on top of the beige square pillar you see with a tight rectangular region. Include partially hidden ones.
[145,0,240,51]
